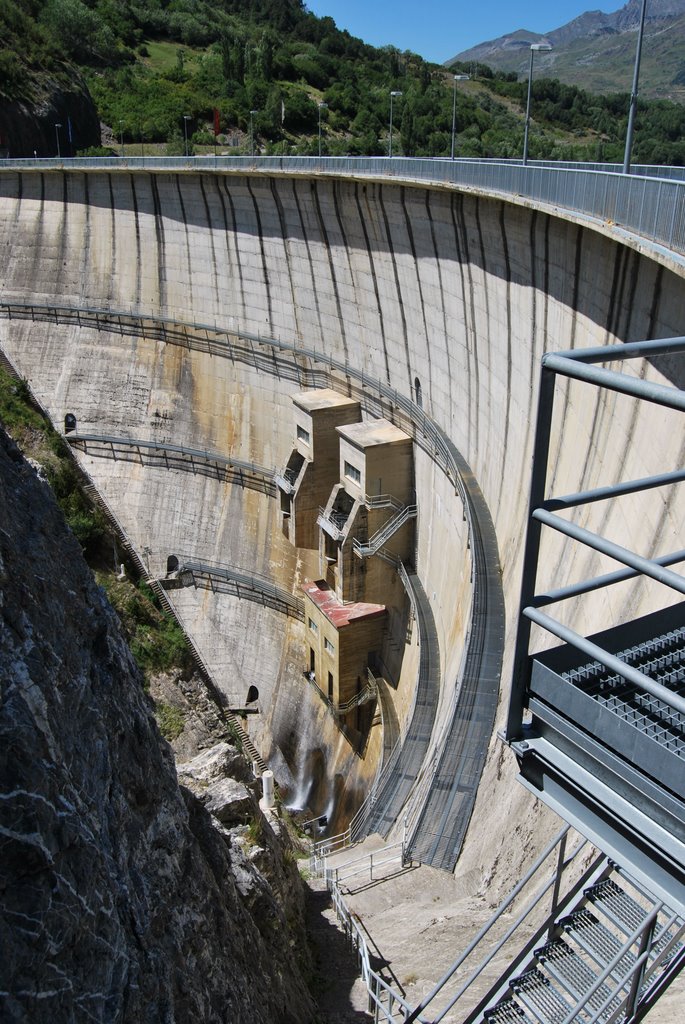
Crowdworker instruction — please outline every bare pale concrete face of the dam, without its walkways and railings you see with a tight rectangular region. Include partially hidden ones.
[0,169,685,876]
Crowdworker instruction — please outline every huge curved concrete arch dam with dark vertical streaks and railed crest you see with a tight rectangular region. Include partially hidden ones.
[0,159,685,974]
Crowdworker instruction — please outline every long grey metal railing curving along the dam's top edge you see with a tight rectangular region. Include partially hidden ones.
[0,156,685,258]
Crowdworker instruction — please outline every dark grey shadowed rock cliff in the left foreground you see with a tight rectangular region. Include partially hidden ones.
[0,431,312,1024]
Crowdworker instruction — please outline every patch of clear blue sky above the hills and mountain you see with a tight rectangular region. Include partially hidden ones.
[305,0,626,63]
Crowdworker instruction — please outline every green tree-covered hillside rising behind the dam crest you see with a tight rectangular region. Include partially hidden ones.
[0,0,685,164]
